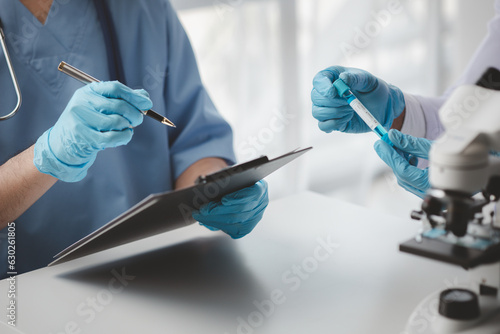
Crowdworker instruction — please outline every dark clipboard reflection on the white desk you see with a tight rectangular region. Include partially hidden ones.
[56,236,262,312]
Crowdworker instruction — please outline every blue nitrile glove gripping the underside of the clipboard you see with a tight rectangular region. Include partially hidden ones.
[193,180,269,239]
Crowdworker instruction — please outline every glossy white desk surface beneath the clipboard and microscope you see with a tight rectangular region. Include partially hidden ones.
[0,193,466,334]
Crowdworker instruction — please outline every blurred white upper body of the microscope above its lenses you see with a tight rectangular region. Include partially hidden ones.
[429,85,500,195]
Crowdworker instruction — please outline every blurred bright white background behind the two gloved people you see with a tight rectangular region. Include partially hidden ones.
[171,0,494,218]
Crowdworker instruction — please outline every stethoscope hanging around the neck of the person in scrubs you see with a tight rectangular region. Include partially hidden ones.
[0,0,125,121]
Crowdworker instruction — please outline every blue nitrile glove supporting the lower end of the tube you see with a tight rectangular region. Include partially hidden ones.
[375,130,432,198]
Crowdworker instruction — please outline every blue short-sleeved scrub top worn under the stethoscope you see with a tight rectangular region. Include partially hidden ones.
[0,0,235,277]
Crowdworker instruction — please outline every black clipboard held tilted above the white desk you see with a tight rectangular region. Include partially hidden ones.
[49,147,312,266]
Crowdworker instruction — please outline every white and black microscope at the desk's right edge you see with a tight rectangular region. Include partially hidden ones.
[400,68,500,334]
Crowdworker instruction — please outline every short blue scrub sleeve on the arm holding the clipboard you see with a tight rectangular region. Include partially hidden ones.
[164,2,236,179]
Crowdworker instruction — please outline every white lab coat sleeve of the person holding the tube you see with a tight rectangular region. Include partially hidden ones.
[401,0,500,139]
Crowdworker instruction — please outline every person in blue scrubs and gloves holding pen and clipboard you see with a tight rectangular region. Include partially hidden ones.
[0,0,268,277]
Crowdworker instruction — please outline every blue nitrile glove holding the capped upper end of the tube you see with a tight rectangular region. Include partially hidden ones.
[311,66,405,133]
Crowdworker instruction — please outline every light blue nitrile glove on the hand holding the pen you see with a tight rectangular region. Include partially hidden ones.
[33,81,153,182]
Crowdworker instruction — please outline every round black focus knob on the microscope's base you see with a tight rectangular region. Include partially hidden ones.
[439,289,480,320]
